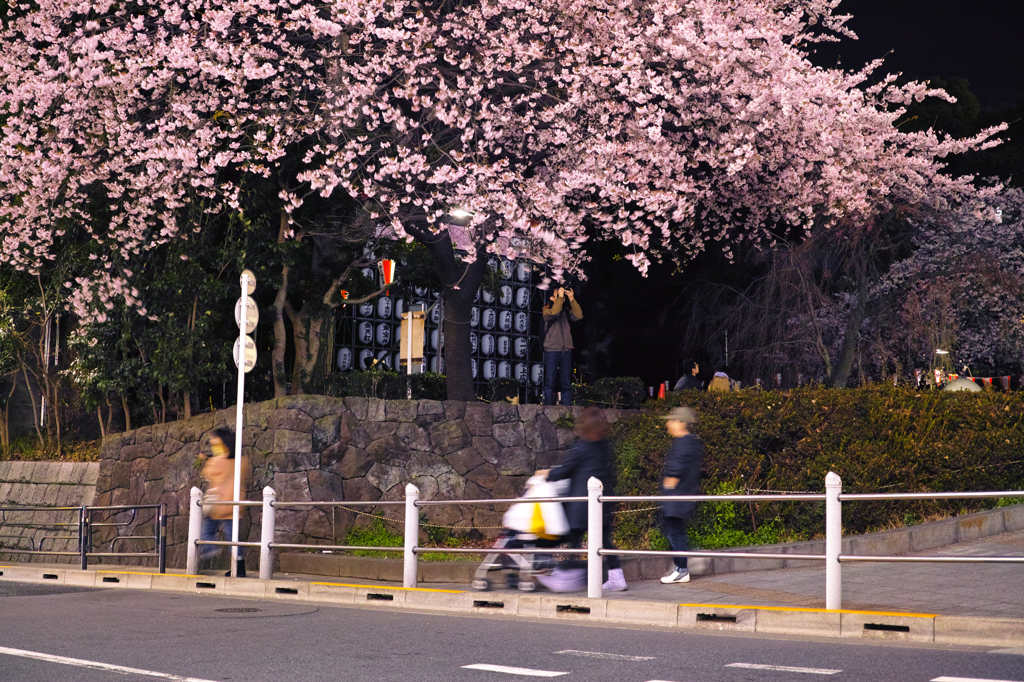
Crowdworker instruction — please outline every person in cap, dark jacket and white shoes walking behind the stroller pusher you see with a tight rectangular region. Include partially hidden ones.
[662,408,703,585]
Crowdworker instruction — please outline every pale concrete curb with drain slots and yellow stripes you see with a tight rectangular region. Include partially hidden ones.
[0,565,1024,647]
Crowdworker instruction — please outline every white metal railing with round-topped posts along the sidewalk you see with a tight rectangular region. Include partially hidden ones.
[186,472,1024,610]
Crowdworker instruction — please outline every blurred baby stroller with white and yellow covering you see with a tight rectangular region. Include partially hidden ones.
[472,476,569,592]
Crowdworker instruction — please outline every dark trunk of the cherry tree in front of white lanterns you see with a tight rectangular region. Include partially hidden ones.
[425,232,487,401]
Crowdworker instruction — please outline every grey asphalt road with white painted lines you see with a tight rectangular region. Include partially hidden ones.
[0,583,1024,682]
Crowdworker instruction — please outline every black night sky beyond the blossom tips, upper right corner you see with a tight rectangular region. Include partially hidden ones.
[815,0,1024,109]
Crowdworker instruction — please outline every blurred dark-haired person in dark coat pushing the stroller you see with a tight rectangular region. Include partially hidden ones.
[537,408,626,592]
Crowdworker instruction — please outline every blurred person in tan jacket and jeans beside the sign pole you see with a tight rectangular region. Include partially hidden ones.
[200,427,248,578]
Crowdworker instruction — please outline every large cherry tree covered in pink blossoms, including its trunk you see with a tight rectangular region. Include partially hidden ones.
[0,0,1003,399]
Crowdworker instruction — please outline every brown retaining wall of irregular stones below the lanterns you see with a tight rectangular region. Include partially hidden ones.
[96,395,622,567]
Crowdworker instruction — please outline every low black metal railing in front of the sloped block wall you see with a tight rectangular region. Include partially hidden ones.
[0,504,167,573]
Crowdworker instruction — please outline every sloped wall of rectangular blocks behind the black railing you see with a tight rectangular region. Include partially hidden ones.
[0,462,99,562]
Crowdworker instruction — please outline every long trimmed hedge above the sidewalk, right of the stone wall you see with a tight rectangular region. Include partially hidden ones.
[614,386,1024,548]
